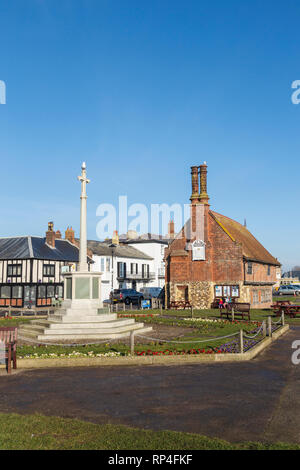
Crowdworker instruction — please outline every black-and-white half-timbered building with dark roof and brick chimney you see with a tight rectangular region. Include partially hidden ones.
[0,223,91,308]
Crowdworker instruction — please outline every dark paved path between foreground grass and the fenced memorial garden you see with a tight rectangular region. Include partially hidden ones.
[0,327,300,443]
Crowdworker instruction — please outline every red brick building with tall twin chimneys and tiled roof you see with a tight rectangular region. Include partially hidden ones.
[165,163,280,309]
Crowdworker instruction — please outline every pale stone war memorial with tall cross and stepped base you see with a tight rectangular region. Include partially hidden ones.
[20,163,152,342]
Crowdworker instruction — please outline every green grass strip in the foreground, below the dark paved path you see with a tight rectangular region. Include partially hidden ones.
[0,413,300,450]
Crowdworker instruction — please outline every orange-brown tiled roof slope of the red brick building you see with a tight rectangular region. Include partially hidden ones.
[210,211,280,266]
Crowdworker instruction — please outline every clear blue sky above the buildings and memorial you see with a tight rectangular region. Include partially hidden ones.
[0,0,300,267]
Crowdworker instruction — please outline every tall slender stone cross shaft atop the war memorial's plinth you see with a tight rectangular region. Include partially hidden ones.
[78,162,90,272]
